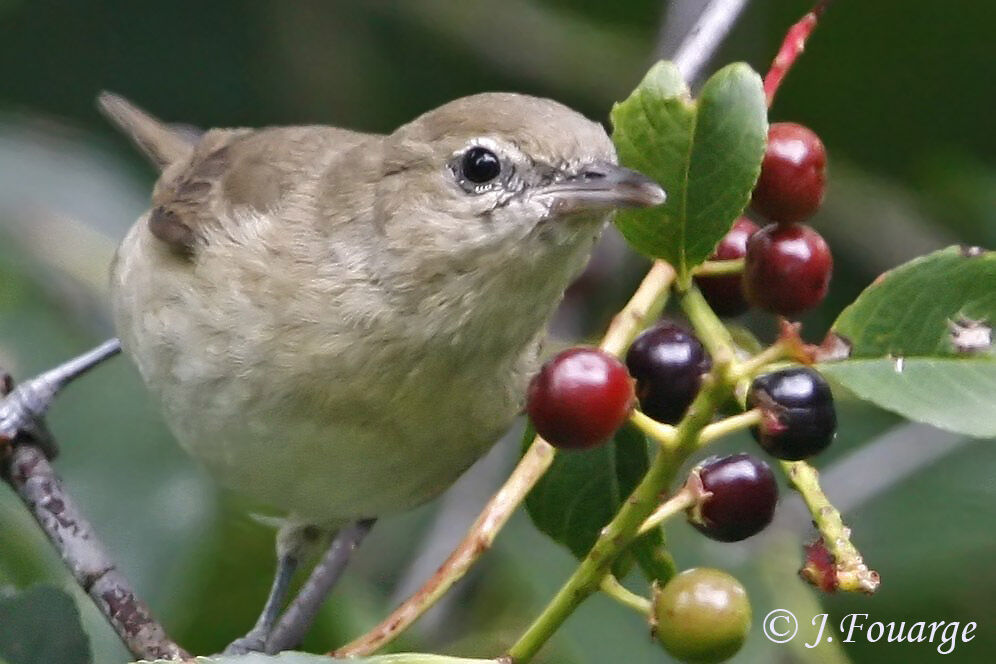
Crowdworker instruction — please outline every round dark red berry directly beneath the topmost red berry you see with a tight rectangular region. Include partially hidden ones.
[744,224,833,316]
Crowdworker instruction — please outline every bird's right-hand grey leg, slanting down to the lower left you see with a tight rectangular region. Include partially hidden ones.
[265,519,375,654]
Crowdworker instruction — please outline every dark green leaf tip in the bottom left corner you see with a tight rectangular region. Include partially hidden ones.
[0,586,91,664]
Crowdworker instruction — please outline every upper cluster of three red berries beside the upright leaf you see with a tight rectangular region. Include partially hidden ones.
[696,122,833,316]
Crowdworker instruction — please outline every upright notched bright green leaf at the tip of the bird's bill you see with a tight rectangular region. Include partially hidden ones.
[612,62,768,283]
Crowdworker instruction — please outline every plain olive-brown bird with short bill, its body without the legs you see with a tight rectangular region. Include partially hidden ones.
[99,93,664,528]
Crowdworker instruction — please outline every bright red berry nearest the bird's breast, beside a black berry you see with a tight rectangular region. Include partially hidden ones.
[526,348,635,449]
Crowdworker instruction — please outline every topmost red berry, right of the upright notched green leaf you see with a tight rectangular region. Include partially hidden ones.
[751,122,827,223]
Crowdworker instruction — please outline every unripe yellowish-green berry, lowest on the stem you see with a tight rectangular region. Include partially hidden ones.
[654,567,751,664]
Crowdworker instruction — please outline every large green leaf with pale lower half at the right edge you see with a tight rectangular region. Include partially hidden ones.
[818,247,996,438]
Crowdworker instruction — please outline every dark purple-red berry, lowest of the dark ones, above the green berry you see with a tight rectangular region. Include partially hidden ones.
[689,454,778,542]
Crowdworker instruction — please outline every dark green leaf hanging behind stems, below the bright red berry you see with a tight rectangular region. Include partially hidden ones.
[526,424,647,558]
